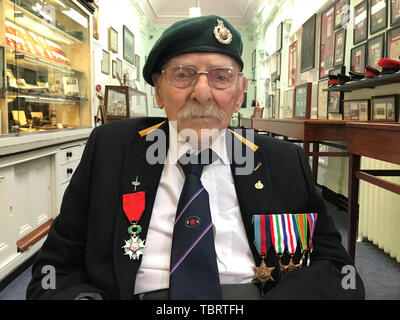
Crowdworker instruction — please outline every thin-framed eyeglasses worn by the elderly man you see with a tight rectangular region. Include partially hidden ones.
[161,66,242,89]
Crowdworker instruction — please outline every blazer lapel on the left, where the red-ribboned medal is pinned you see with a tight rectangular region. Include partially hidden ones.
[114,121,169,299]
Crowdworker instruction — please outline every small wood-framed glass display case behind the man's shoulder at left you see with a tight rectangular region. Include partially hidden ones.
[104,86,148,121]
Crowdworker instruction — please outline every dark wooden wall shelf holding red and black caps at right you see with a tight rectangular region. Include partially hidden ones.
[324,71,400,92]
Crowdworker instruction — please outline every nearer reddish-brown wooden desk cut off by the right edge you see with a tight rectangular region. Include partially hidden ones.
[346,122,400,259]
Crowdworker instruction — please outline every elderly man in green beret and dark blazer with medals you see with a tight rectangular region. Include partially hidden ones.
[27,15,364,299]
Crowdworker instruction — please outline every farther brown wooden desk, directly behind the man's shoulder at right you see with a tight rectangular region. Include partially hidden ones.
[253,119,349,183]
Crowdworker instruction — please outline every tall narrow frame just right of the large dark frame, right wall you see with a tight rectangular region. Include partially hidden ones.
[319,6,335,79]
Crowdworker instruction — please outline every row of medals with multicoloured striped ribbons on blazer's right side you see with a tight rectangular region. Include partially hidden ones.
[253,213,317,286]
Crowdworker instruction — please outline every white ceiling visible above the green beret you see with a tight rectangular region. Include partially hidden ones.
[139,0,262,26]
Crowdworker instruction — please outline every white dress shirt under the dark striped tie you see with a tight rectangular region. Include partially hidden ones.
[134,123,254,294]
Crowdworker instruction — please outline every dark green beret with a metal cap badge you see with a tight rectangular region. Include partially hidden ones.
[143,15,243,86]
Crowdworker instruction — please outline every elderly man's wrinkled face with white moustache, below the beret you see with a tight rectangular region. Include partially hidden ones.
[154,53,246,142]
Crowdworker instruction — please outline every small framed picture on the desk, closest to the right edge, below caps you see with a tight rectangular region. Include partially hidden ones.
[371,95,399,122]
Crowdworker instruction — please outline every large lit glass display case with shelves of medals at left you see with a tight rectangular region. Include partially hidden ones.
[0,0,92,135]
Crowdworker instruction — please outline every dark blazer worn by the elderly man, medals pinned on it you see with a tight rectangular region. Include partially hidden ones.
[27,118,364,299]
